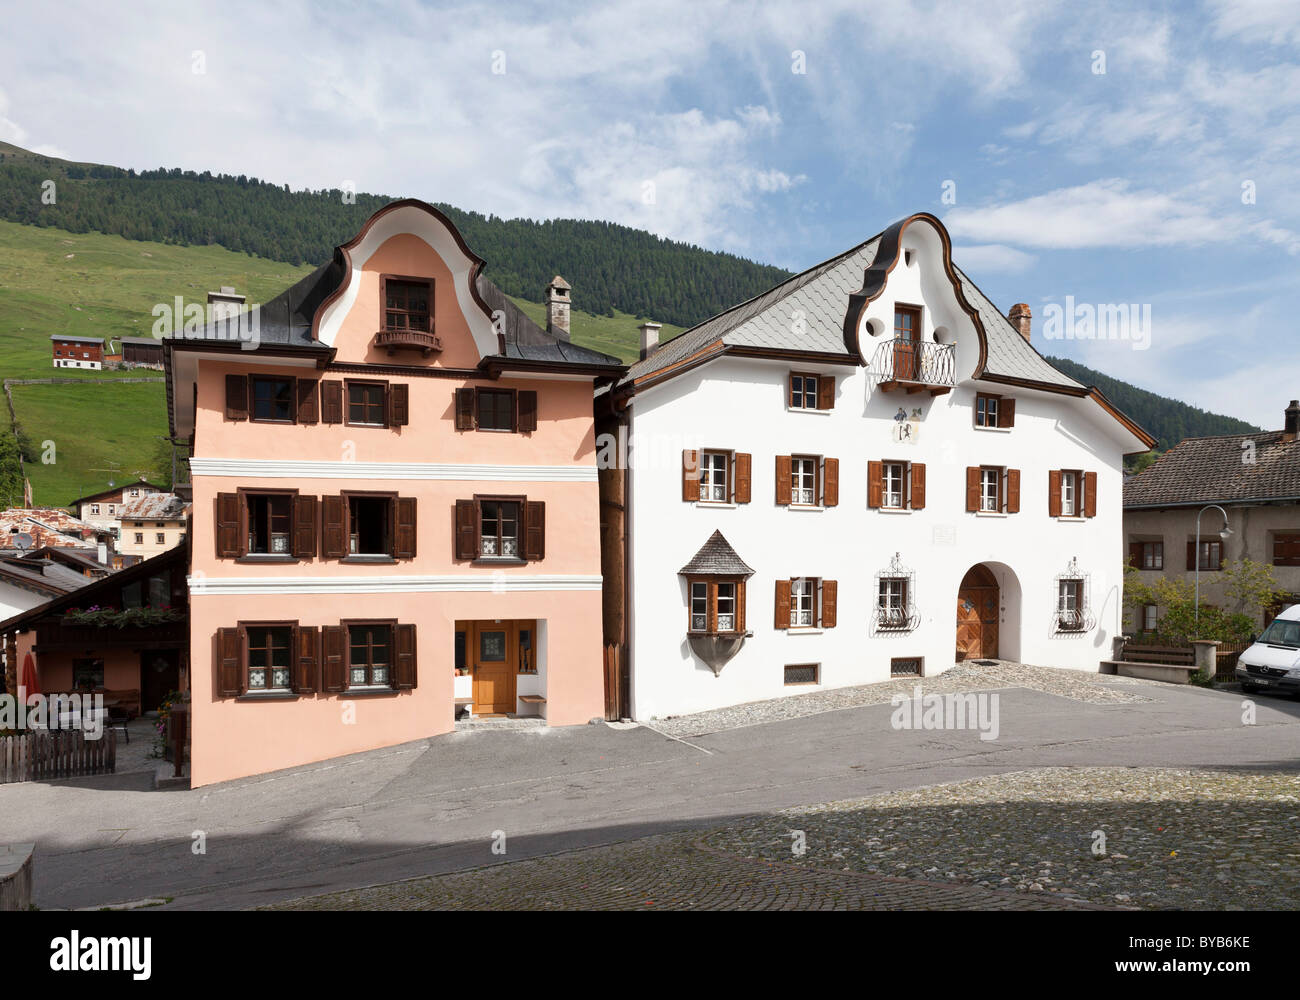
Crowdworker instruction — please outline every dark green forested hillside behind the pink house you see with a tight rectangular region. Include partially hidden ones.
[0,143,789,326]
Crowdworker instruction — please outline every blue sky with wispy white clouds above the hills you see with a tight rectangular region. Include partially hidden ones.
[0,0,1300,428]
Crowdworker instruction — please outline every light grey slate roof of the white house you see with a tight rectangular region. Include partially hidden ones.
[621,215,1084,389]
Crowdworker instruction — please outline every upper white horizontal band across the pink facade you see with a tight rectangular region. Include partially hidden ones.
[190,458,595,482]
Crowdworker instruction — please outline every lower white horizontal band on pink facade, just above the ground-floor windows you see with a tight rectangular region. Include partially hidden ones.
[186,573,601,597]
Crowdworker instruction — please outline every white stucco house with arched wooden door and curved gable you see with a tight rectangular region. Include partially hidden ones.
[598,213,1153,719]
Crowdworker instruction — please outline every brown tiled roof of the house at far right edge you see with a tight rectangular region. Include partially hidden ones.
[1125,430,1300,508]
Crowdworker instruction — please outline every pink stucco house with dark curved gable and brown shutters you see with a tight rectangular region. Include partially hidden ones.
[165,200,621,785]
